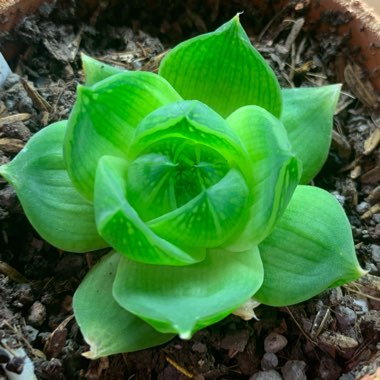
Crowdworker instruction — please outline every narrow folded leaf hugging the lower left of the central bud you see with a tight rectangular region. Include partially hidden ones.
[94,156,205,265]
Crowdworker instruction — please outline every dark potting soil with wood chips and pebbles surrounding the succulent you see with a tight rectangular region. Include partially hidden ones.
[0,0,380,380]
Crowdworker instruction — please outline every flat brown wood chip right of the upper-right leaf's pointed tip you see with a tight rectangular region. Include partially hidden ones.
[344,63,379,109]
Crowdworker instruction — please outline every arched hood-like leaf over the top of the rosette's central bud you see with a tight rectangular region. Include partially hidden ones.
[129,100,248,180]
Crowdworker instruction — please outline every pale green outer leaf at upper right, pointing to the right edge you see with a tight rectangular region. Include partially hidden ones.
[281,85,341,184]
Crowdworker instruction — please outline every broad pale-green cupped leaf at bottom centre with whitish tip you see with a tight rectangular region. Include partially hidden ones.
[113,247,263,339]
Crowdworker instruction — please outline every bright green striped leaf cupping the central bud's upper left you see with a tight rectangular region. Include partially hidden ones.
[64,71,181,200]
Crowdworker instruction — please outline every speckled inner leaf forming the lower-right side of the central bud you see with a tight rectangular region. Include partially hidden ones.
[148,169,249,248]
